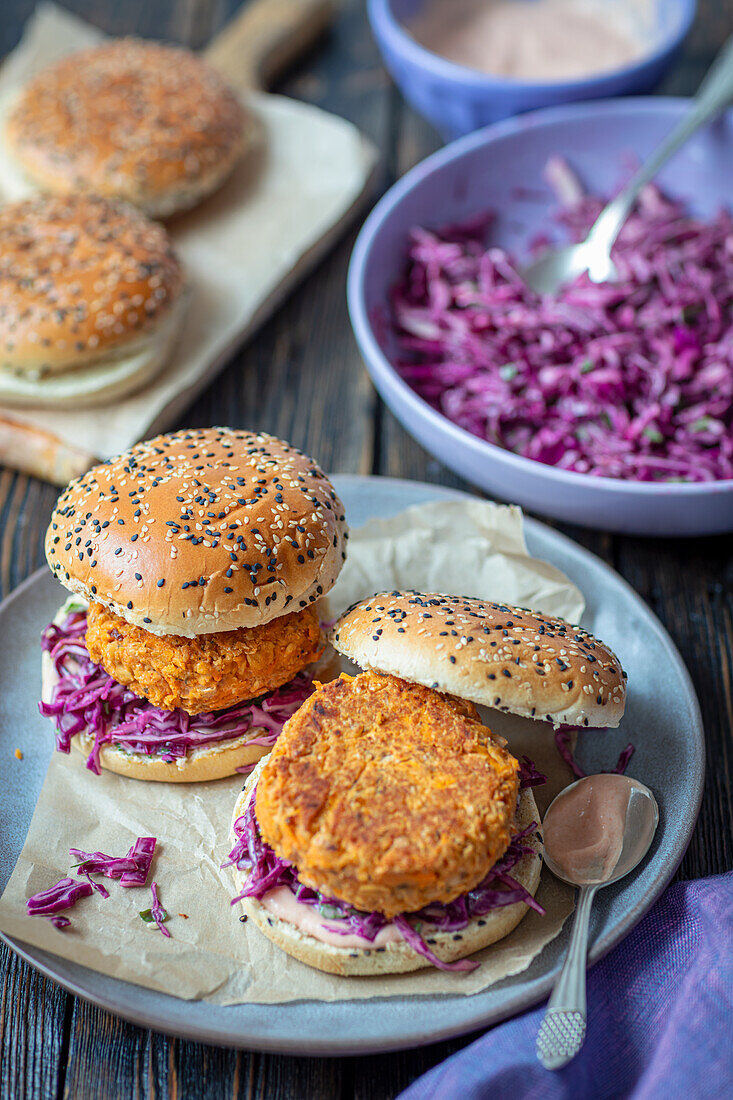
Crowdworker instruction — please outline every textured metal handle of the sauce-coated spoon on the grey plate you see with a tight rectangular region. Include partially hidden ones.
[537,886,598,1069]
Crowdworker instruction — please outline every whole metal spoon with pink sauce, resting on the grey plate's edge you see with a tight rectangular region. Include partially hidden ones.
[530,773,659,1069]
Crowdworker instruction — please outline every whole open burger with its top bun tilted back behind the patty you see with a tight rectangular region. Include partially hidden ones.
[229,592,624,975]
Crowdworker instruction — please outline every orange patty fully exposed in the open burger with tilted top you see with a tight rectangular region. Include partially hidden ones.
[256,672,518,917]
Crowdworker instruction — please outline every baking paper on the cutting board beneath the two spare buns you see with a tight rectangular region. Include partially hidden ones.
[0,2,376,458]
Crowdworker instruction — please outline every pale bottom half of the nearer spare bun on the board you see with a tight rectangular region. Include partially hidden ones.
[0,290,190,408]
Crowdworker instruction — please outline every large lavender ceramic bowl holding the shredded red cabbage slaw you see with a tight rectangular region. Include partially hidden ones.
[347,98,733,536]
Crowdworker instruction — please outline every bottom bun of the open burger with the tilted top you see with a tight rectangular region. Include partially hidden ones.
[231,757,541,977]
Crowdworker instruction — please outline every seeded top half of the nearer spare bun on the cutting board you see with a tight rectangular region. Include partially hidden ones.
[0,195,184,376]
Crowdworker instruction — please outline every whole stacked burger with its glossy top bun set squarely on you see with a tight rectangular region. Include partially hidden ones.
[41,428,348,782]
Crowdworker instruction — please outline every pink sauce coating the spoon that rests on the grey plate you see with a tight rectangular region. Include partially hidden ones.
[543,774,631,883]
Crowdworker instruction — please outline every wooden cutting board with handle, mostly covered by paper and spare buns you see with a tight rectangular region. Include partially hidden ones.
[0,0,367,485]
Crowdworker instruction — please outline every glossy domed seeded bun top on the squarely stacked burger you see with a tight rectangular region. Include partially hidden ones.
[46,428,348,638]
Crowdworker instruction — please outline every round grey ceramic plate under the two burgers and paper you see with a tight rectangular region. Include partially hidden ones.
[0,476,704,1055]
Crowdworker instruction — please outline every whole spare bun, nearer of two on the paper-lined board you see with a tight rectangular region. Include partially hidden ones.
[0,195,185,407]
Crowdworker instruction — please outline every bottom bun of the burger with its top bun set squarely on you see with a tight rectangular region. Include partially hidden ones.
[41,608,340,783]
